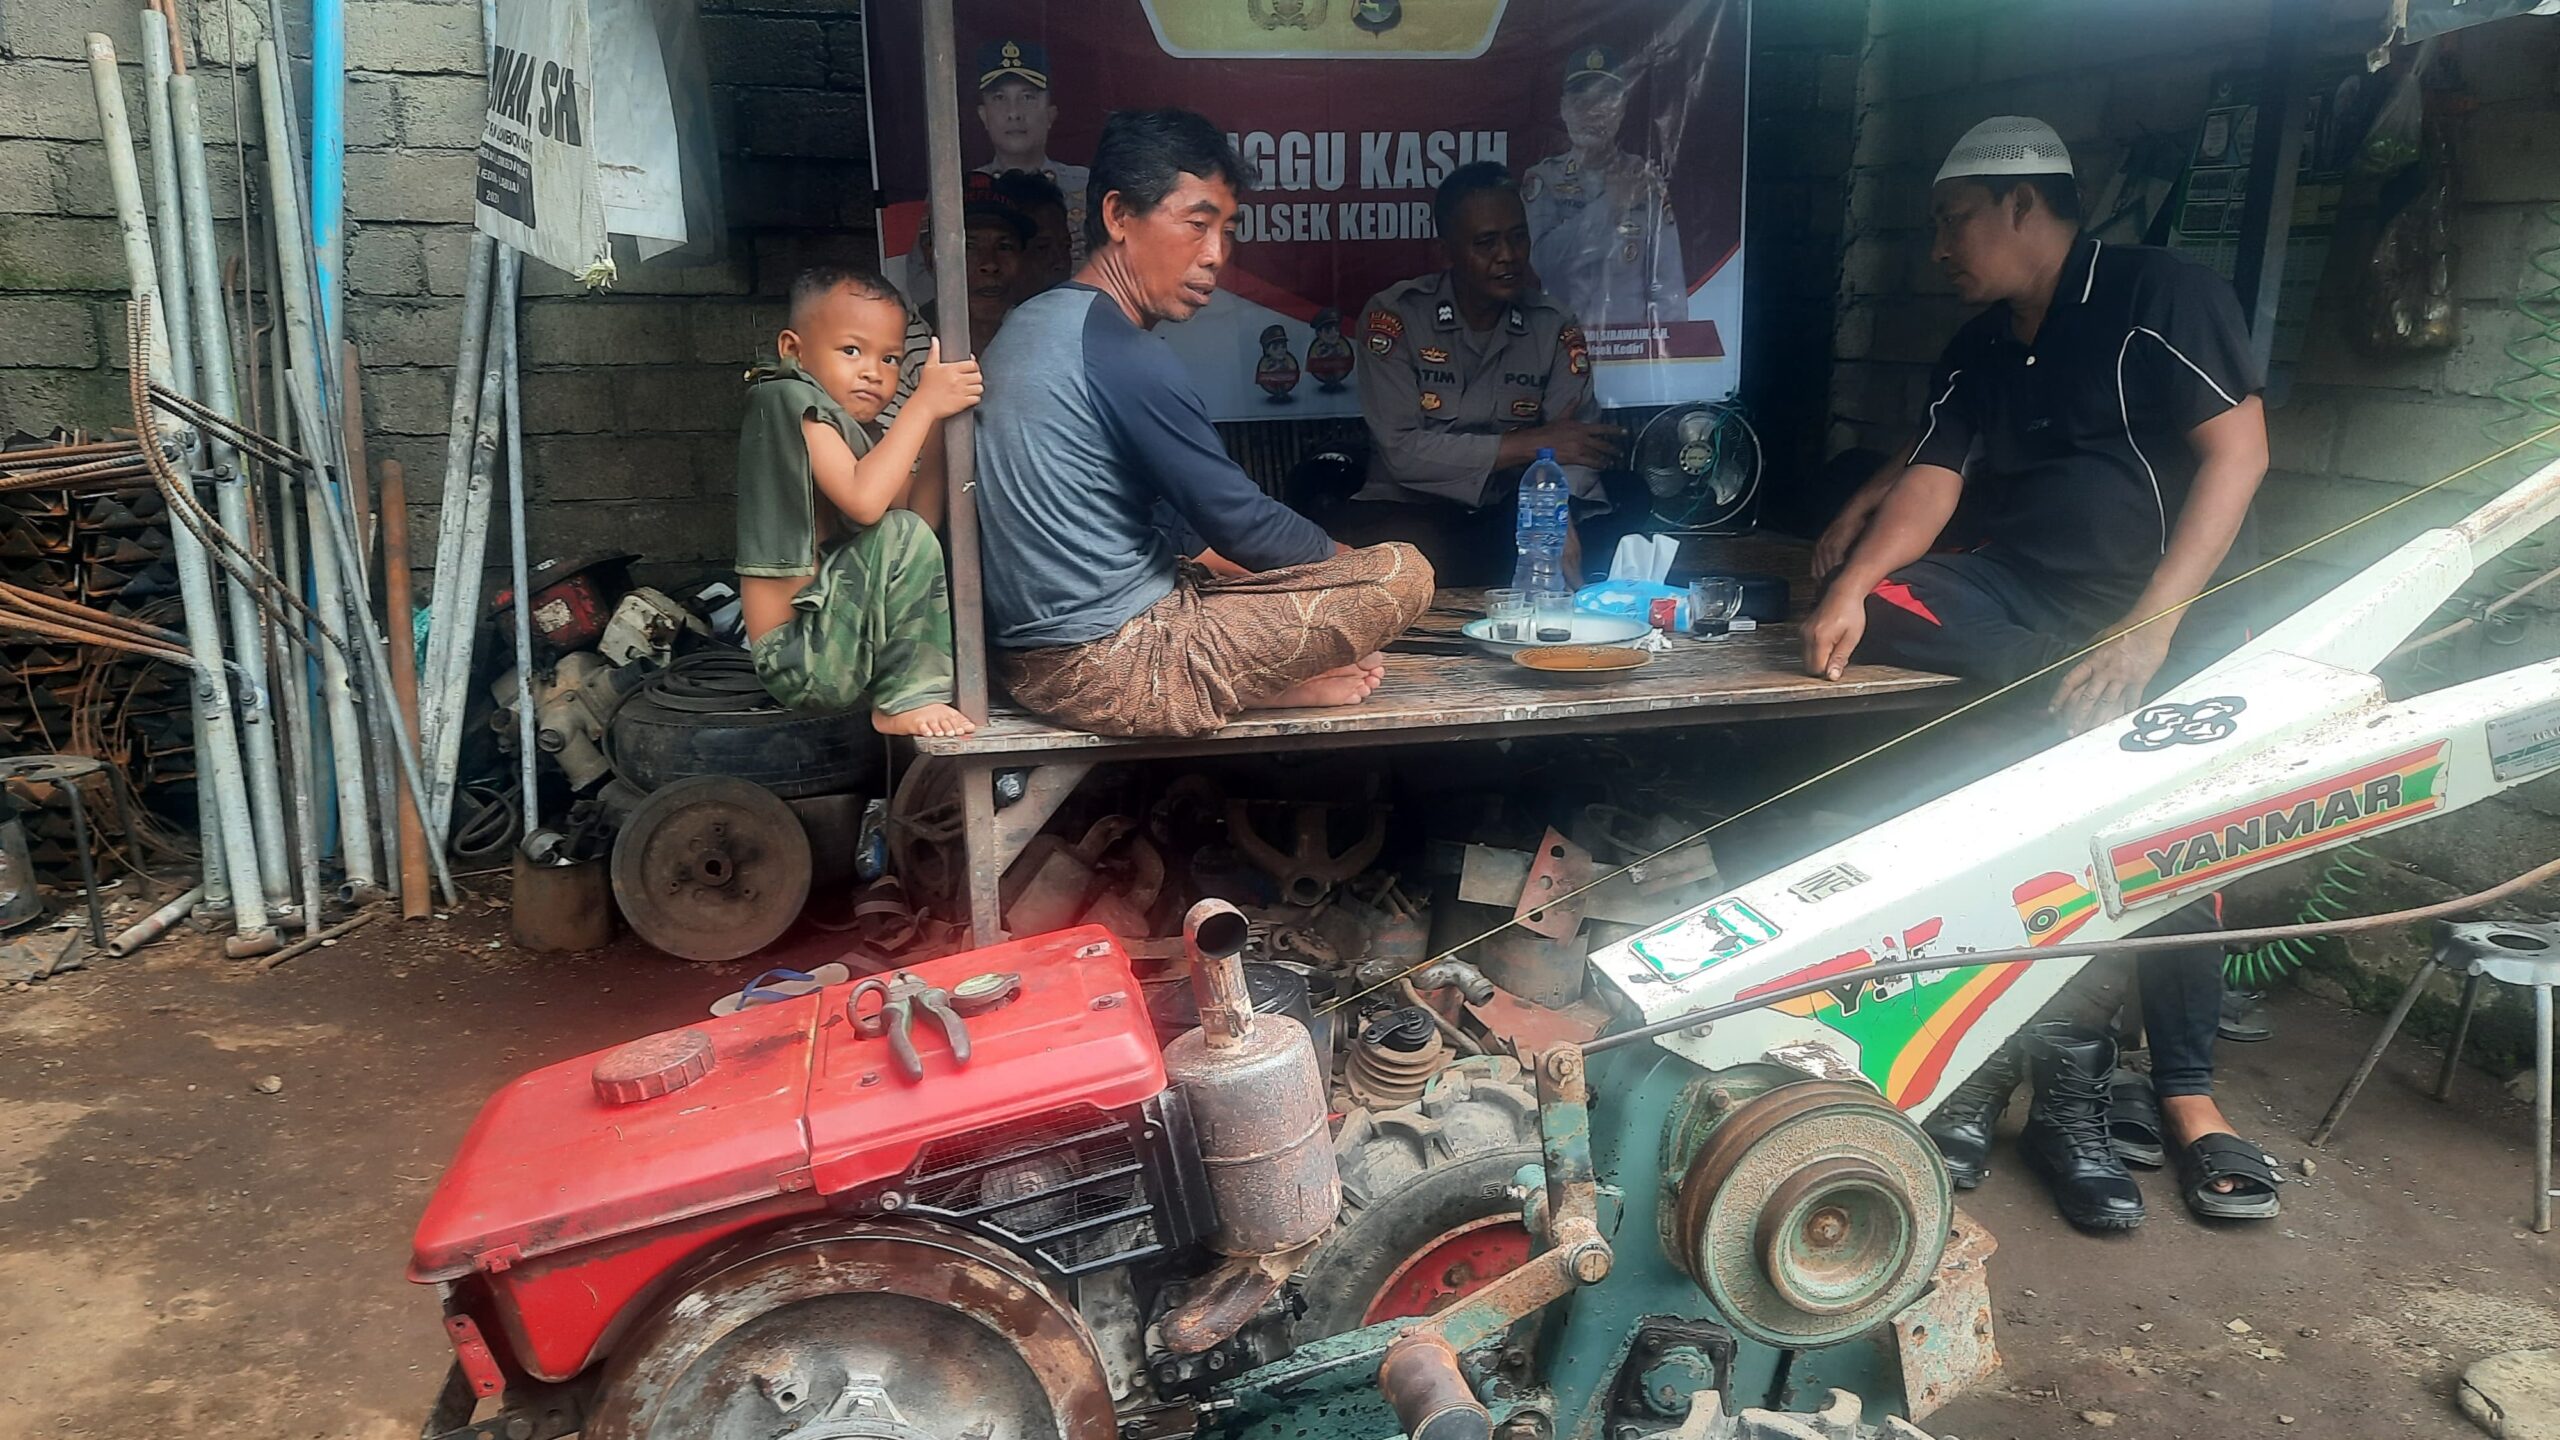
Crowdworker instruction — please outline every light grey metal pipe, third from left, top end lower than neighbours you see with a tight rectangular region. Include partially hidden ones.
[169,74,295,910]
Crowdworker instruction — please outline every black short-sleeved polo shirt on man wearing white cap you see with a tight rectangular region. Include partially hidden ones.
[1910,238,2266,607]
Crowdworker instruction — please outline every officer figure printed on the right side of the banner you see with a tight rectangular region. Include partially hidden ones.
[1521,46,1690,331]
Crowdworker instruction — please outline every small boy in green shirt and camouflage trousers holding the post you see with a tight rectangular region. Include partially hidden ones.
[737,264,983,735]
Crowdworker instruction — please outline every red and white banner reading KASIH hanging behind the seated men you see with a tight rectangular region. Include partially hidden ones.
[865,0,1748,420]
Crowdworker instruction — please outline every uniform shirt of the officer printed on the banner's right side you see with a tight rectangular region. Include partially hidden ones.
[1521,151,1690,328]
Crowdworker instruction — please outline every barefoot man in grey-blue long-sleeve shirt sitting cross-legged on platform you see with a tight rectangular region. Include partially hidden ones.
[978,110,1431,735]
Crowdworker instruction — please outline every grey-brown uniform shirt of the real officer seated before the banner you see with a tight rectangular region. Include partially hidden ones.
[1357,272,1600,510]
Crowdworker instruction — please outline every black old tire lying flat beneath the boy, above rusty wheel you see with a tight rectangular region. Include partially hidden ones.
[604,651,881,799]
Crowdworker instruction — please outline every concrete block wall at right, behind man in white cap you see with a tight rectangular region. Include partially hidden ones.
[1832,0,2560,1030]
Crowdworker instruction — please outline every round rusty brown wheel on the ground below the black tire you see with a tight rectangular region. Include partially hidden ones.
[612,774,809,961]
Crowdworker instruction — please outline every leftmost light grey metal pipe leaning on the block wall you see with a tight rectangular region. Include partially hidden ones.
[87,33,274,945]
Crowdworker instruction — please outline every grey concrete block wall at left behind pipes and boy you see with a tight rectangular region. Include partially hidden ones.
[0,0,876,594]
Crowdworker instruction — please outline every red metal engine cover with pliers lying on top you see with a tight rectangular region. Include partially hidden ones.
[410,925,1165,1381]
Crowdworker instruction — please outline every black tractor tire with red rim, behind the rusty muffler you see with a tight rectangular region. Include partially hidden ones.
[1298,1040,1541,1345]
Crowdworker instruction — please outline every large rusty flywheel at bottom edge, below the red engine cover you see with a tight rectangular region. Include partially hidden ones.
[581,1220,1119,1440]
